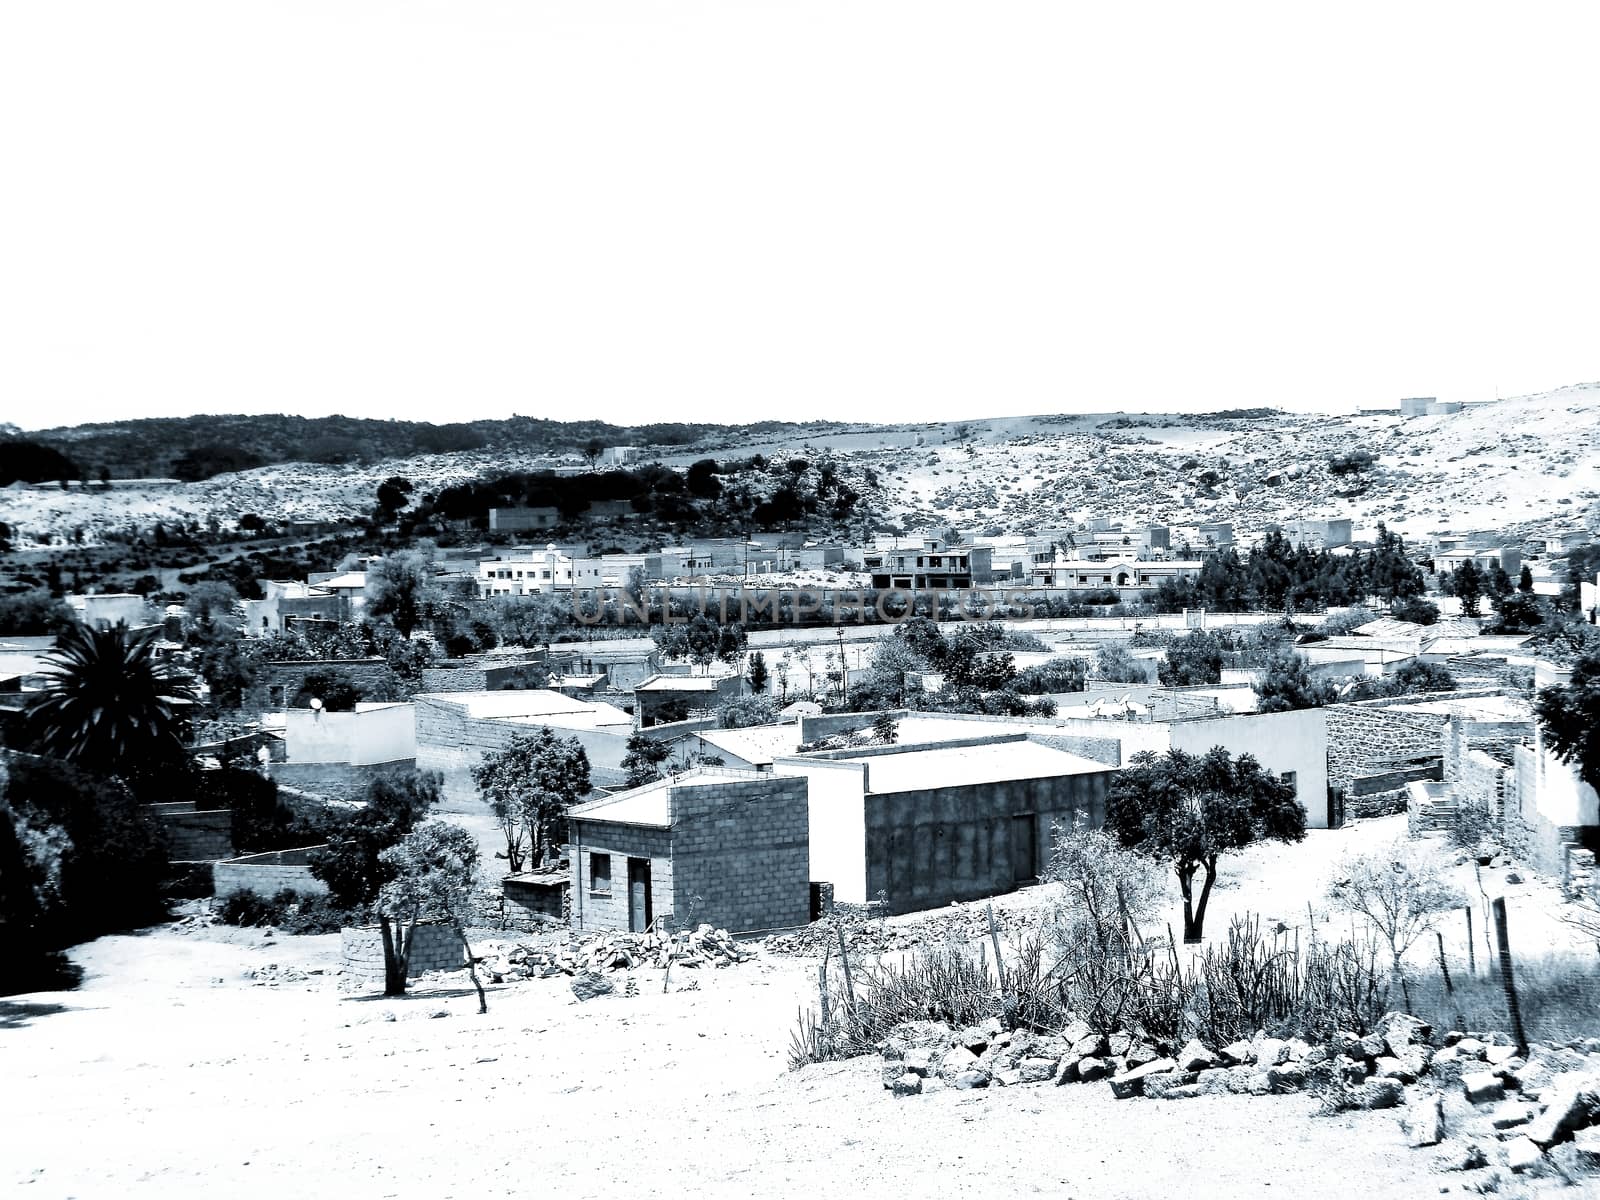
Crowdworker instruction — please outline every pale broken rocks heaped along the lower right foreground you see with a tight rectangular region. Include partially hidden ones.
[878,1013,1600,1190]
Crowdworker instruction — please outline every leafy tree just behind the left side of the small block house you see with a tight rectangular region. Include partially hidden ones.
[472,726,589,875]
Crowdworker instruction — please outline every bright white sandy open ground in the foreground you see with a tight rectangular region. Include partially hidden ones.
[0,930,1432,1197]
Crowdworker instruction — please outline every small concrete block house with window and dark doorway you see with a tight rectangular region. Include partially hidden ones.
[566,768,811,933]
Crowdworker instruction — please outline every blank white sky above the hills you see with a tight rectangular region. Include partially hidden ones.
[0,0,1600,427]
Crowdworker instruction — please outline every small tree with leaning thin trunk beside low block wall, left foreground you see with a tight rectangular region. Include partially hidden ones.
[378,821,490,1013]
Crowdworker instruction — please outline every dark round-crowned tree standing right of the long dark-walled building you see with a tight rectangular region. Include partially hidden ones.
[1106,746,1306,942]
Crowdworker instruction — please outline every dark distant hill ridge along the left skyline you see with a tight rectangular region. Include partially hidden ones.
[27,414,870,480]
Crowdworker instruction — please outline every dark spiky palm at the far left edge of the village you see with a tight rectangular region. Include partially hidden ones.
[27,622,194,774]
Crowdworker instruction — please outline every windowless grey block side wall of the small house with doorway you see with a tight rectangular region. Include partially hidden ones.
[672,776,811,933]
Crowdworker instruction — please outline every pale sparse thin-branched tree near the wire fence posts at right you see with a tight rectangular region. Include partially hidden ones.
[1328,837,1467,1011]
